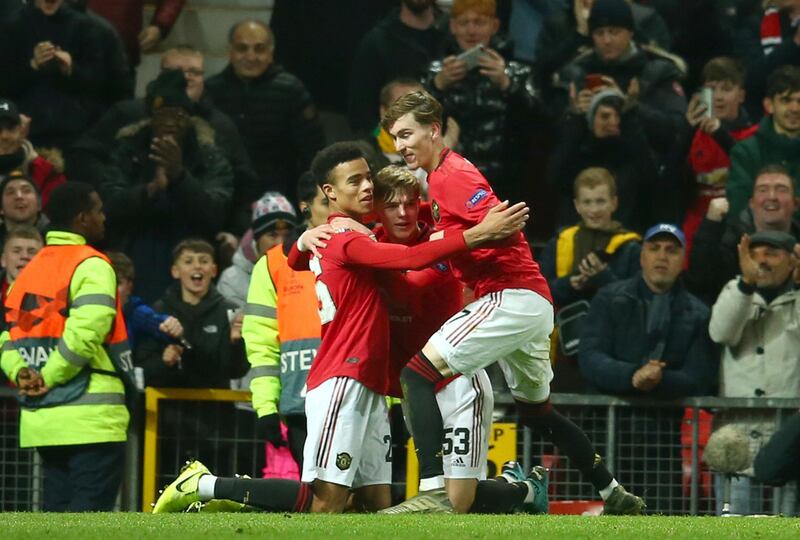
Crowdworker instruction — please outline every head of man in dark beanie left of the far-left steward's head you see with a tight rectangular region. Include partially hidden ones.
[0,171,49,247]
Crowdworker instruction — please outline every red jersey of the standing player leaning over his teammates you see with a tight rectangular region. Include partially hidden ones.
[428,148,553,303]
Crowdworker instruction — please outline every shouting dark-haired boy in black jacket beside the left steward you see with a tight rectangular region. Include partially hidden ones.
[136,239,246,388]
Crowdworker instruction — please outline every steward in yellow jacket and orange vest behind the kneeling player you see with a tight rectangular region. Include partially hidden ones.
[242,172,329,469]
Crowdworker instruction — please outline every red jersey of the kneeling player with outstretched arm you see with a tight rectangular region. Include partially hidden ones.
[289,215,467,395]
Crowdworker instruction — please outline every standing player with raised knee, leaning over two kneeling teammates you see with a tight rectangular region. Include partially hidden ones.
[382,91,645,514]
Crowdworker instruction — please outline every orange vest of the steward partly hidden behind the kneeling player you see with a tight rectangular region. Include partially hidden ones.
[266,245,322,414]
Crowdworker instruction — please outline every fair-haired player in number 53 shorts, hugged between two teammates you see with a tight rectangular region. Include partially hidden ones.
[374,165,547,513]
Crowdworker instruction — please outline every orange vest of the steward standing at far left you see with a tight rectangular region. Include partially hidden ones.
[5,245,133,408]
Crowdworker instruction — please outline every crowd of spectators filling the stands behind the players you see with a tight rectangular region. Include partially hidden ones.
[0,0,800,511]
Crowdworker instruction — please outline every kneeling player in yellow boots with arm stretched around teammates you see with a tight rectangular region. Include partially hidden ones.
[154,143,527,512]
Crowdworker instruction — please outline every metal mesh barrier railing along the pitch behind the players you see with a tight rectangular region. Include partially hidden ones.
[0,388,800,515]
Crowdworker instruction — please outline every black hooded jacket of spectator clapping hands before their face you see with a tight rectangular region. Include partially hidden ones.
[99,116,233,303]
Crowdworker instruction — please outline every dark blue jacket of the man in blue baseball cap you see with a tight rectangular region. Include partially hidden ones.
[578,274,719,399]
